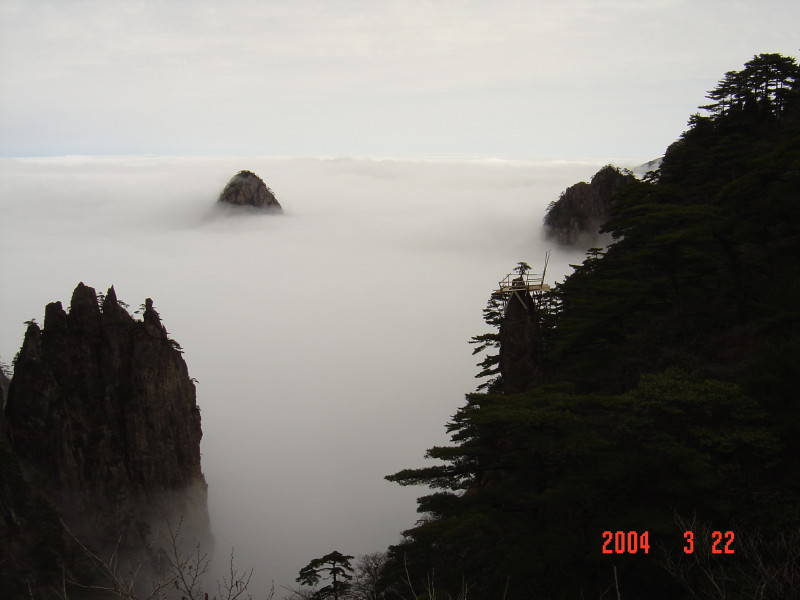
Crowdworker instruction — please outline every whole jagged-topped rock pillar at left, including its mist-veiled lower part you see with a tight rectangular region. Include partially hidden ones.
[0,283,210,596]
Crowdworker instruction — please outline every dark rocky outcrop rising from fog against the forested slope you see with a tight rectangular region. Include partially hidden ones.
[544,165,635,244]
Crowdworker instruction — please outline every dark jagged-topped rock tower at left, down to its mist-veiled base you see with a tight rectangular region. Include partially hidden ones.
[6,283,202,492]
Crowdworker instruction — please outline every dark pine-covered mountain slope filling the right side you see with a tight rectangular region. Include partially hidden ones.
[383,54,800,599]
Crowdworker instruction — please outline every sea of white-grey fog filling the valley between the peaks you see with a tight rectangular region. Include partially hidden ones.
[0,157,616,587]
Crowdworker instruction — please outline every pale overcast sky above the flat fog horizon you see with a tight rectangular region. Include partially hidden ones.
[0,0,800,159]
